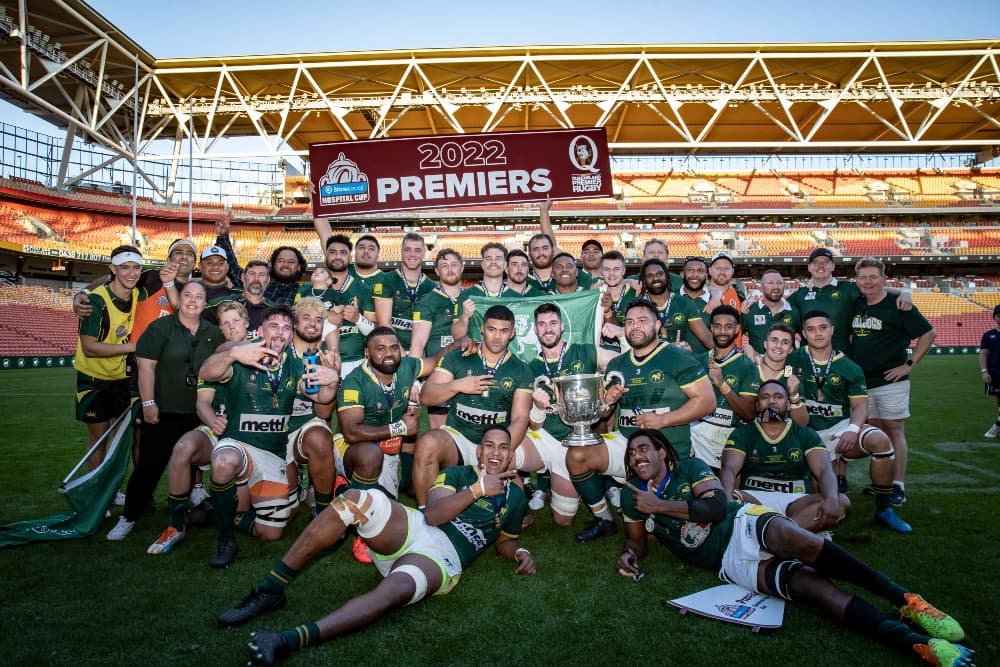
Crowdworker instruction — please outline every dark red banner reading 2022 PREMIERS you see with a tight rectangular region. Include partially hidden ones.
[309,128,612,217]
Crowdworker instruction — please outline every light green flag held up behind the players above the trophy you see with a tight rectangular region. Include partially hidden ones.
[469,289,602,363]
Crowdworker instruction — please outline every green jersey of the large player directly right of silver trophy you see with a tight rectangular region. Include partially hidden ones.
[607,343,708,459]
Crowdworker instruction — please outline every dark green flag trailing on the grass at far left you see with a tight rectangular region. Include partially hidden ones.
[0,401,138,547]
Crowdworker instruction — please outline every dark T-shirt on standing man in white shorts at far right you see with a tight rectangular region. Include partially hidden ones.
[850,294,934,389]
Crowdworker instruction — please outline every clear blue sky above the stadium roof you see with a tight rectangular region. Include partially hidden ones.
[0,0,1000,134]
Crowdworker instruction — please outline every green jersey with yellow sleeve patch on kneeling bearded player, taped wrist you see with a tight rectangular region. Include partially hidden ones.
[337,357,423,426]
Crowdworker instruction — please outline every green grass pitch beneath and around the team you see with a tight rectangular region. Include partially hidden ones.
[0,356,1000,667]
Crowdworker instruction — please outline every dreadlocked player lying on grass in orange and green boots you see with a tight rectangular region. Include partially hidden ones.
[617,429,973,667]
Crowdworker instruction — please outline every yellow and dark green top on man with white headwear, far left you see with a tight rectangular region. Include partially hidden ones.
[73,285,146,380]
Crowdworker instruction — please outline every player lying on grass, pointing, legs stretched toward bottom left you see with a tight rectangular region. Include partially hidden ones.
[219,426,535,665]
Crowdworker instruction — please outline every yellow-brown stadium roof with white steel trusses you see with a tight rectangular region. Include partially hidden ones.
[0,0,1000,172]
